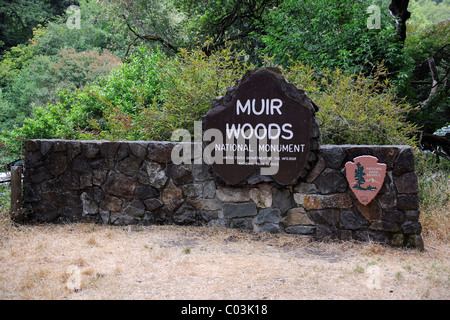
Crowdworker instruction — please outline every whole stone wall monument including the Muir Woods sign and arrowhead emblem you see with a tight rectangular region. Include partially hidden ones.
[23,68,424,249]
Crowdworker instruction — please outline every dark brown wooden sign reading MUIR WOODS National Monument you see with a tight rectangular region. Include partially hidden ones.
[203,68,314,184]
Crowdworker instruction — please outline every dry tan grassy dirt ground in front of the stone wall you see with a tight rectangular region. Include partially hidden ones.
[0,224,450,300]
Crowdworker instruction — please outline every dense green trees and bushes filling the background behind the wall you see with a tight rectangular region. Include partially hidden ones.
[0,0,450,165]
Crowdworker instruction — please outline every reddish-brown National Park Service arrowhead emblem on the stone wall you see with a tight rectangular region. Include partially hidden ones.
[345,156,386,205]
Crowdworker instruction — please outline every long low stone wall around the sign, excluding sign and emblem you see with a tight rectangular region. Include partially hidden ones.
[24,140,423,248]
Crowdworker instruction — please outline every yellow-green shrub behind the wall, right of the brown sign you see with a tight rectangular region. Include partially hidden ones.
[285,62,417,145]
